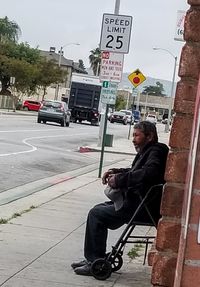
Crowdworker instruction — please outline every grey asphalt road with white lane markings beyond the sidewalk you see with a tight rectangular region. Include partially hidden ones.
[0,114,134,195]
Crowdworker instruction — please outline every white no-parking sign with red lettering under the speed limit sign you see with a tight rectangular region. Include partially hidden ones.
[100,51,124,83]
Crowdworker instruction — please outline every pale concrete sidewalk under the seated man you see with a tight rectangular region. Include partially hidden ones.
[0,131,170,287]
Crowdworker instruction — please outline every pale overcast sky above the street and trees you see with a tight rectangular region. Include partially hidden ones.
[0,0,189,80]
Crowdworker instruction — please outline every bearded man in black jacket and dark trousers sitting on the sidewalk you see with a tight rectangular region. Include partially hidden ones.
[71,121,169,275]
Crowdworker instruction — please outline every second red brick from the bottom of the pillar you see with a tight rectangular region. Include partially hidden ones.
[156,218,181,253]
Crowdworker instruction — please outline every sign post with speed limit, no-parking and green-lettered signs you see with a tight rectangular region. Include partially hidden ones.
[98,5,132,177]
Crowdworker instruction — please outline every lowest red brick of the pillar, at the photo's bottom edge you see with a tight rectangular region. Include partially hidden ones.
[151,253,177,287]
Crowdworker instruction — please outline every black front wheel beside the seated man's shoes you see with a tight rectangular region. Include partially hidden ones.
[91,258,112,280]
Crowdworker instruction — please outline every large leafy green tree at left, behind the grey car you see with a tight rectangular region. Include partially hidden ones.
[0,43,66,97]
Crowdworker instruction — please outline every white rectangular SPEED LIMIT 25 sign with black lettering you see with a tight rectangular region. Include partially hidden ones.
[100,14,132,54]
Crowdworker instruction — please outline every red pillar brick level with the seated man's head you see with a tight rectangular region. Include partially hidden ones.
[169,115,193,149]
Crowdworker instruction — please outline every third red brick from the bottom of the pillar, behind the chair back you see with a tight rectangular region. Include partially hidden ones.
[161,184,184,218]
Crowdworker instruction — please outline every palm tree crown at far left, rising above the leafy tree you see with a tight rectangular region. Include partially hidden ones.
[0,16,21,43]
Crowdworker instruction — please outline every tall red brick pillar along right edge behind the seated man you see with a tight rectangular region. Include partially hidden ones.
[151,0,200,287]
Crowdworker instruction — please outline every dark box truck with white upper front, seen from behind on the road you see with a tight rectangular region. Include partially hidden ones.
[69,73,102,125]
